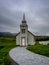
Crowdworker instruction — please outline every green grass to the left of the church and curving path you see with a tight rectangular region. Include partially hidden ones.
[0,37,16,65]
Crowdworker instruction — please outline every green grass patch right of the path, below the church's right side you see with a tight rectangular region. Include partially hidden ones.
[27,42,49,57]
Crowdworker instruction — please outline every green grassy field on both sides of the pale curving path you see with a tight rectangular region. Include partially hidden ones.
[0,37,49,65]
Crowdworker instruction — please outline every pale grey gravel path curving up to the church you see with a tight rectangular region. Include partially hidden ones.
[9,47,49,65]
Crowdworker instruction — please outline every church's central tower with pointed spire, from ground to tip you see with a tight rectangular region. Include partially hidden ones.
[20,13,28,46]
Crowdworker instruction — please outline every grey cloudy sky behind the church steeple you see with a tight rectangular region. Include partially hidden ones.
[0,0,49,35]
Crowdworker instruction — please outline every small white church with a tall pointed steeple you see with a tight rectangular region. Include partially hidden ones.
[16,14,35,46]
